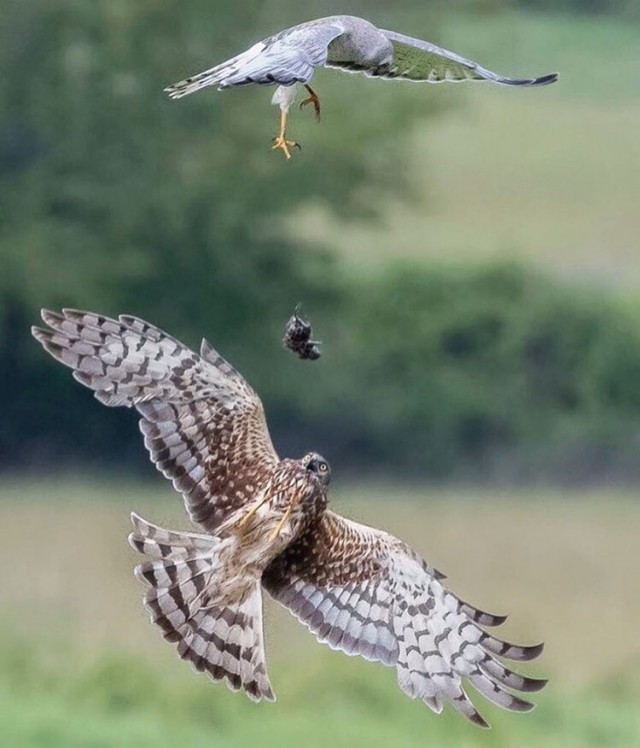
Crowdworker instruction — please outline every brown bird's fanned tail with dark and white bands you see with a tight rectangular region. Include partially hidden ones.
[129,514,275,701]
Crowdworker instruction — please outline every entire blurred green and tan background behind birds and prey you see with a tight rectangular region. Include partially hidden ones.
[0,0,640,748]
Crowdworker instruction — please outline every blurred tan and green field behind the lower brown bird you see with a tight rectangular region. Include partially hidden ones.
[0,479,640,748]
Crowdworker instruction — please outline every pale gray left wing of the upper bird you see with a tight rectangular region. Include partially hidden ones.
[165,19,345,99]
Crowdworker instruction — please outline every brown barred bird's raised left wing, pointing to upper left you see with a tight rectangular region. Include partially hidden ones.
[32,309,278,531]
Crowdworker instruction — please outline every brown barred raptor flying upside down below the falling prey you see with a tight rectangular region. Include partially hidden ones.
[32,309,546,726]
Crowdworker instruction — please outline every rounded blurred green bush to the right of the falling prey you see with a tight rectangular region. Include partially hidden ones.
[320,266,640,482]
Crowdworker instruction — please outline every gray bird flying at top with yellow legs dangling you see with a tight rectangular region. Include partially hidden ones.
[165,16,558,159]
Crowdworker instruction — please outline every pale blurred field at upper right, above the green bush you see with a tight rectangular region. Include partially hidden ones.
[291,13,640,288]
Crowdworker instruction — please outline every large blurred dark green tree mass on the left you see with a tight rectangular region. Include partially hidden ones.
[0,0,438,474]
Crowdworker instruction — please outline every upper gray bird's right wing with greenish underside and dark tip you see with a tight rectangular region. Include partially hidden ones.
[364,29,558,86]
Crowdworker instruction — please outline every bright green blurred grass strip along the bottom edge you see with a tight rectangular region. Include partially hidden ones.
[0,637,638,748]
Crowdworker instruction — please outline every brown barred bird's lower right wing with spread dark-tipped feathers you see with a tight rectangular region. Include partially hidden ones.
[263,512,546,727]
